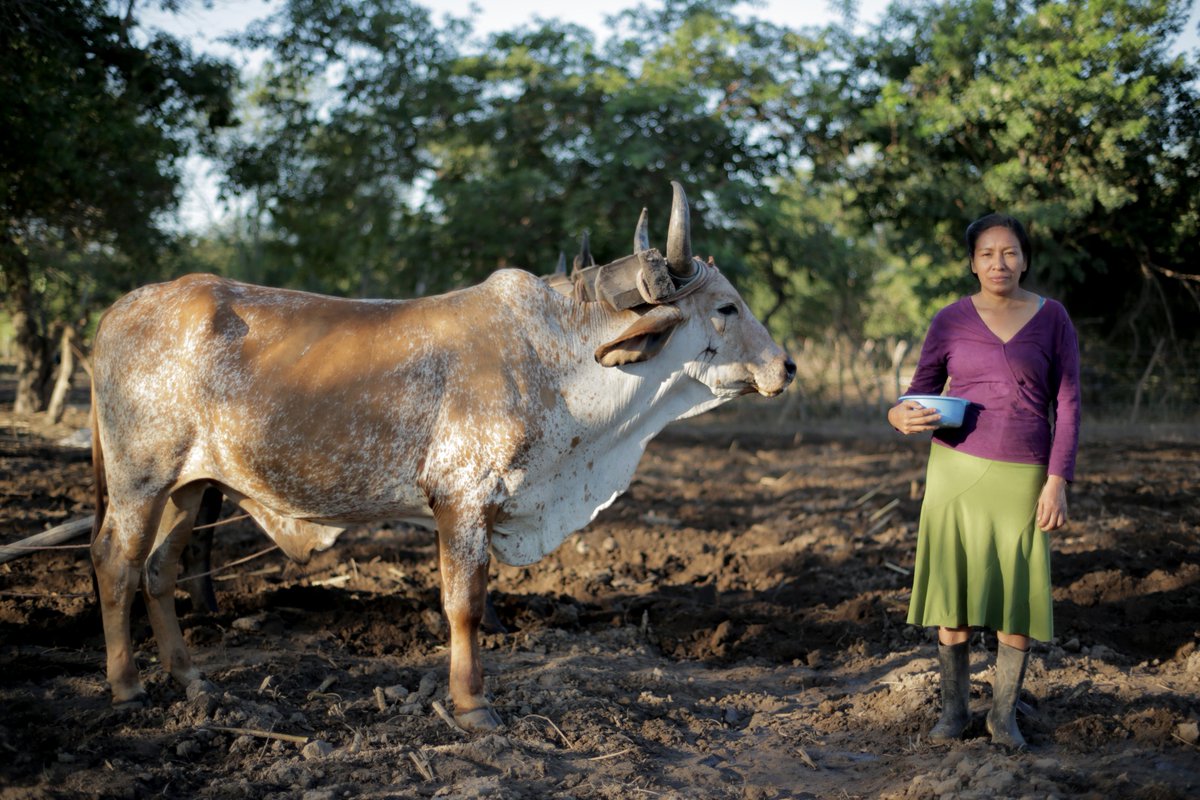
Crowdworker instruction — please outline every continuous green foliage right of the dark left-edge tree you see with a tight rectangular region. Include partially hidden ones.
[206,0,1200,391]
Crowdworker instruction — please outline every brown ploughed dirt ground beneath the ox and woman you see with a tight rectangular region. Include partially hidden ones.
[0,400,1200,800]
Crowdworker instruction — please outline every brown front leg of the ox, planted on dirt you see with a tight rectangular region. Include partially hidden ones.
[434,509,502,730]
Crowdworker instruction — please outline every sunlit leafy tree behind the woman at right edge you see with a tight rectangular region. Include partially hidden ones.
[805,0,1200,337]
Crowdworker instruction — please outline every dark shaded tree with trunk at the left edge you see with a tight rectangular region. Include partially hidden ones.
[0,0,235,411]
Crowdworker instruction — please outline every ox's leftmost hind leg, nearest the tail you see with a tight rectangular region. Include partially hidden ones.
[91,498,162,705]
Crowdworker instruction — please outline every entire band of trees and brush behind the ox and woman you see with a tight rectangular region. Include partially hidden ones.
[0,0,1200,420]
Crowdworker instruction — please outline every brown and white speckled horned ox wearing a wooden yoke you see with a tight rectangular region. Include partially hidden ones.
[91,185,796,729]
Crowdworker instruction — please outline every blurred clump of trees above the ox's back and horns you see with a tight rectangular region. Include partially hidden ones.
[220,0,811,294]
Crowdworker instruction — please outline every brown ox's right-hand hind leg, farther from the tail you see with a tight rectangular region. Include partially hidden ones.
[142,486,211,686]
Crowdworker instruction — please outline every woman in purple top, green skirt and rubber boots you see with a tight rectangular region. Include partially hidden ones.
[888,213,1080,748]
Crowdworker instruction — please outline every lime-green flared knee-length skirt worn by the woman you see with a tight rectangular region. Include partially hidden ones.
[908,444,1054,642]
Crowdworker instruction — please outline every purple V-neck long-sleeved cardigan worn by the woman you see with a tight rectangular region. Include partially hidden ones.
[906,297,1080,481]
